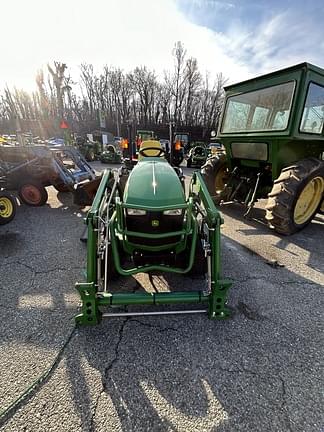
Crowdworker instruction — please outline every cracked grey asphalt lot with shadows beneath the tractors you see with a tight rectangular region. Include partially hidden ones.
[0,164,324,432]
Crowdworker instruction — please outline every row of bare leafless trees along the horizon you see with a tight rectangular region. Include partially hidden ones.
[0,42,226,138]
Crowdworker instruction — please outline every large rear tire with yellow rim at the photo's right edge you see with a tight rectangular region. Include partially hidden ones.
[266,158,324,235]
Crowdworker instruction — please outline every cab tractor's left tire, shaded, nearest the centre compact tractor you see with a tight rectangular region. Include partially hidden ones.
[201,153,228,204]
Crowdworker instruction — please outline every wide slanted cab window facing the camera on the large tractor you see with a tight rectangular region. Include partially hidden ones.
[222,81,295,133]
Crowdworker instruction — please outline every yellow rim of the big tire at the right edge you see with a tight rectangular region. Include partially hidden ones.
[294,177,324,225]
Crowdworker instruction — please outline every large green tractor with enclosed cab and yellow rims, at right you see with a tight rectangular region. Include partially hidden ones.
[202,63,324,235]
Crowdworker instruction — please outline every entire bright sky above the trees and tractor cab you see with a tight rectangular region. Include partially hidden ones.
[0,0,324,91]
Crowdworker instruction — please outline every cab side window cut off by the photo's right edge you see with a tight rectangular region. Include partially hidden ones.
[300,83,324,134]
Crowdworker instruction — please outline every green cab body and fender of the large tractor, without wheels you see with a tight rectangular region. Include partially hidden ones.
[217,63,324,179]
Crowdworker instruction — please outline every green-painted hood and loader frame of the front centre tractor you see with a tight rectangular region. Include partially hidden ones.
[76,158,231,325]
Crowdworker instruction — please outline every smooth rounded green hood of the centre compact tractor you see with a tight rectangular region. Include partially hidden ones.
[124,157,186,209]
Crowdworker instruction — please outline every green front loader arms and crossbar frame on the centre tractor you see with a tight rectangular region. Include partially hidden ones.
[75,170,232,325]
